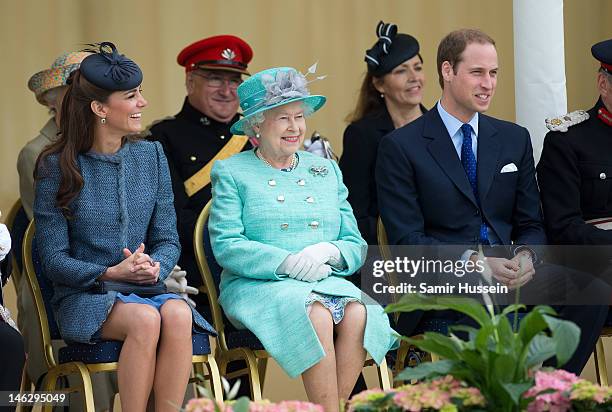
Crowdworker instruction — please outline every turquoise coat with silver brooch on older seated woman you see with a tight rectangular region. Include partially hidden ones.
[209,151,396,377]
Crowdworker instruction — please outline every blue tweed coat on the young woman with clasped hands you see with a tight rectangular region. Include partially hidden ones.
[34,141,214,343]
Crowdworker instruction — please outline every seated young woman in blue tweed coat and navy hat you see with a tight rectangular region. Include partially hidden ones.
[34,43,213,411]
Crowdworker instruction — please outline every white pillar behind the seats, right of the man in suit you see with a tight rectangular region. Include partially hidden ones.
[513,0,567,163]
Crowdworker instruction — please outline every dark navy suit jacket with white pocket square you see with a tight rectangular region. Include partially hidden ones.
[376,108,546,249]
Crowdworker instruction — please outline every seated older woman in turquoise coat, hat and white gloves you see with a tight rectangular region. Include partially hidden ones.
[209,67,396,411]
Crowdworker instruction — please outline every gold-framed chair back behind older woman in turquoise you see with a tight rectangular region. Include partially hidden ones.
[193,201,233,350]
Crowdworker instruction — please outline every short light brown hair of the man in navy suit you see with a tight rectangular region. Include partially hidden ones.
[437,29,495,89]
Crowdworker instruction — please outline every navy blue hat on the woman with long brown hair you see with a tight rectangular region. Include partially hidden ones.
[81,42,142,91]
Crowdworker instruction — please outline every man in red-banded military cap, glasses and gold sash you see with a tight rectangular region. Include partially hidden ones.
[149,35,253,303]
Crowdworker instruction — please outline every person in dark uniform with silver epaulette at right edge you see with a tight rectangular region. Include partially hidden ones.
[537,39,612,269]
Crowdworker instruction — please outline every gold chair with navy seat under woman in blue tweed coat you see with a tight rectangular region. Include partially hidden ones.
[23,221,223,412]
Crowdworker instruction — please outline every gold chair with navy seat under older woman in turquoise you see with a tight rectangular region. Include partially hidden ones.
[193,201,391,400]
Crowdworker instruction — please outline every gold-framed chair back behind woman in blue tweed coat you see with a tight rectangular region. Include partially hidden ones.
[22,220,61,369]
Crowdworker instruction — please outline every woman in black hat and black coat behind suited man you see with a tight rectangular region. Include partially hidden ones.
[340,21,426,245]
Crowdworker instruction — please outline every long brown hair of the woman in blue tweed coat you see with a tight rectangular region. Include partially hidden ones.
[34,70,113,218]
